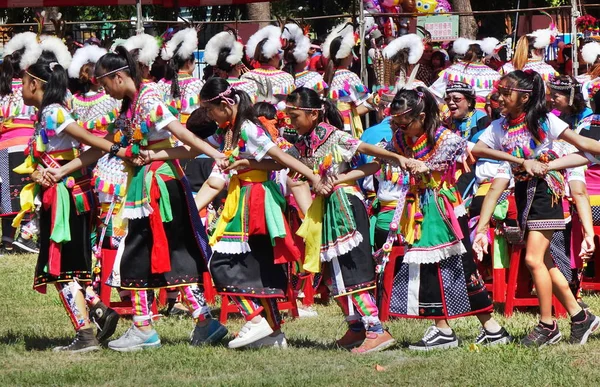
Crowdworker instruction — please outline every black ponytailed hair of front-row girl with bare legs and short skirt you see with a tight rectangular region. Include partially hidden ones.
[500,70,548,141]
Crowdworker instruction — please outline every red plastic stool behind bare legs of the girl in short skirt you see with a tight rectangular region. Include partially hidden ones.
[504,246,567,318]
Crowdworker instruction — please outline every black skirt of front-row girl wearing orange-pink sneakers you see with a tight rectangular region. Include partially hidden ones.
[323,194,376,297]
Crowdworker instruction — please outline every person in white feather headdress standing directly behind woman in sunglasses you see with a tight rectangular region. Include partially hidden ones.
[430,38,500,113]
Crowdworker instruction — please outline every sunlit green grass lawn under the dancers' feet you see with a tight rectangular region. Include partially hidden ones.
[0,255,600,387]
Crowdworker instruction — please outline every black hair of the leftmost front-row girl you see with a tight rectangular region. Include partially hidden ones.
[27,51,69,115]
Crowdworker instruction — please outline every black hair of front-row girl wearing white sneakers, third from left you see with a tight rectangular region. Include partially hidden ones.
[200,77,261,144]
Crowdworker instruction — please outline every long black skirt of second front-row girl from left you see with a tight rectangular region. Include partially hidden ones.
[120,180,210,289]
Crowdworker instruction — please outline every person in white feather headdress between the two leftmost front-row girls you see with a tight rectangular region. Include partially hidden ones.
[68,45,121,141]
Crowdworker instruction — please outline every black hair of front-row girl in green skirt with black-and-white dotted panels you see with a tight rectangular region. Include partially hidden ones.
[390,86,442,146]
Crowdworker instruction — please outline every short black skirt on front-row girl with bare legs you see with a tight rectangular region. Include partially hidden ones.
[515,178,565,232]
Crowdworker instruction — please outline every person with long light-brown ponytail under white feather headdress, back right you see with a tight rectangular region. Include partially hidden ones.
[500,23,559,82]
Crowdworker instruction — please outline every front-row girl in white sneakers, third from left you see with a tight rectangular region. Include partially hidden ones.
[200,78,320,348]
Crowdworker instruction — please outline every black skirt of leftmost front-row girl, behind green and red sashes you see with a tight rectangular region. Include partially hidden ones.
[33,186,92,287]
